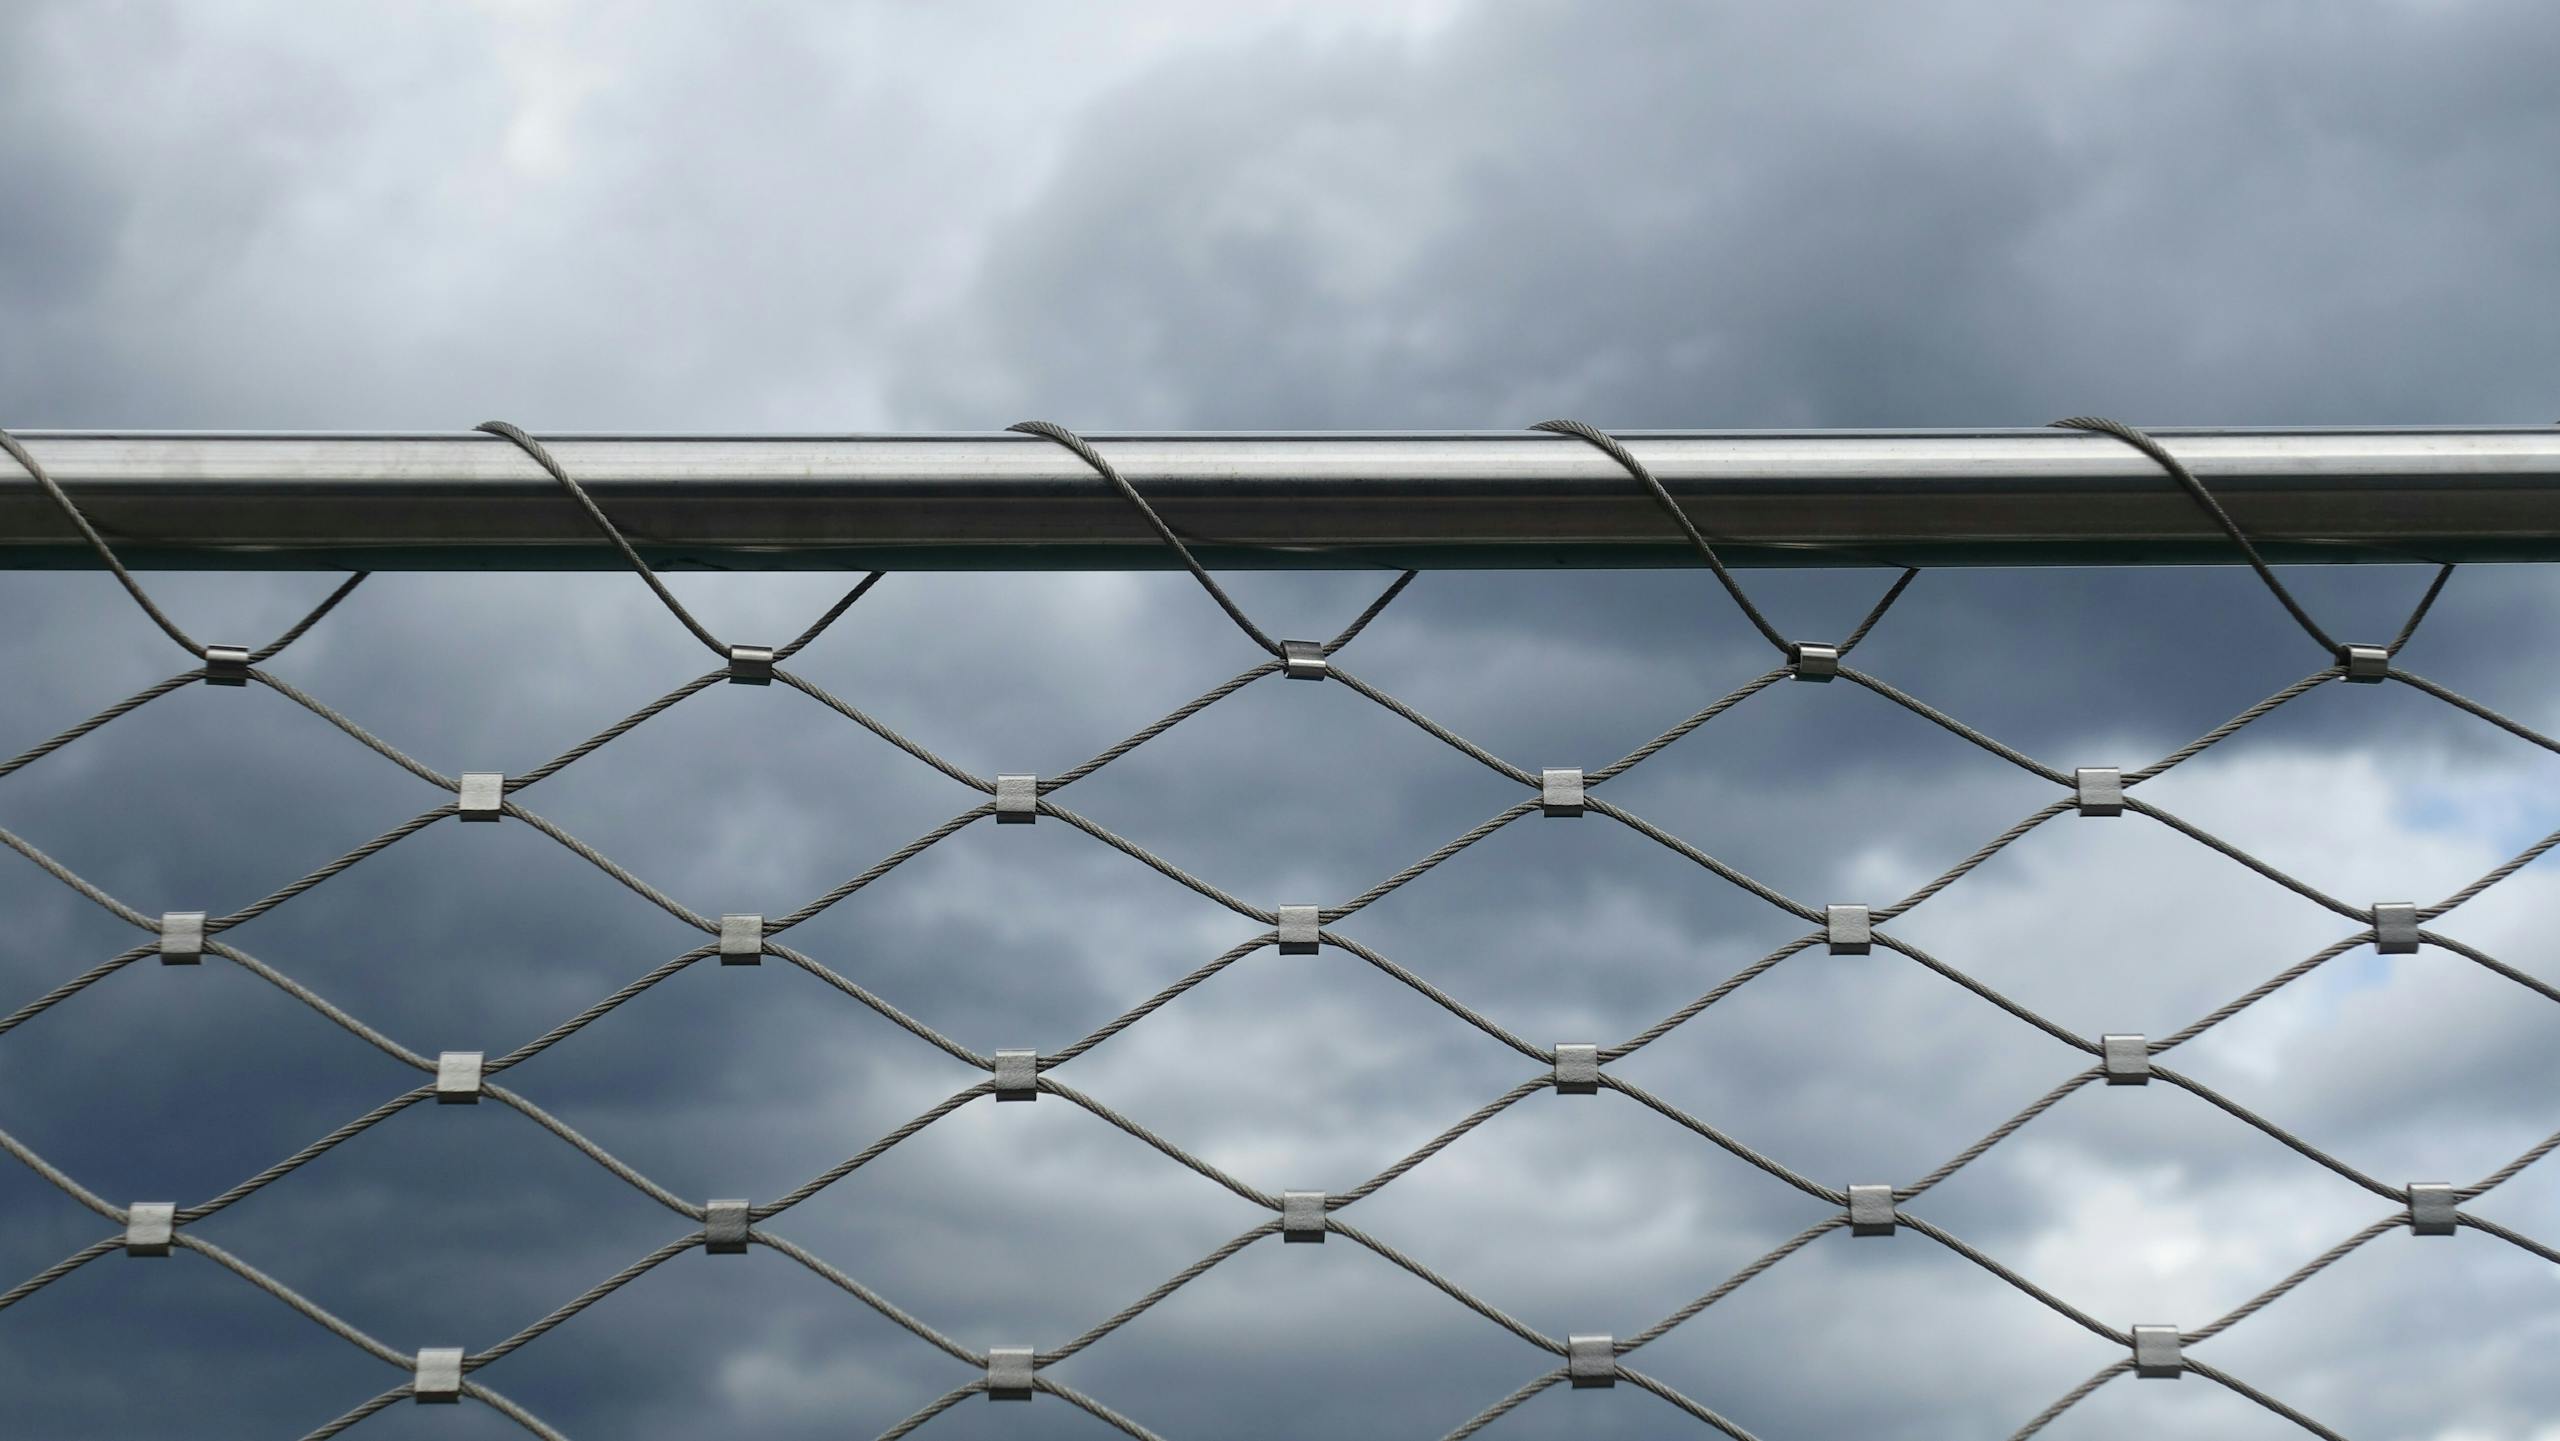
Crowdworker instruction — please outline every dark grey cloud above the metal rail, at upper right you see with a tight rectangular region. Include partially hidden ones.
[901,3,2560,427]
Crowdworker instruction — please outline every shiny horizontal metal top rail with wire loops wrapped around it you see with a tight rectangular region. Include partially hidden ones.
[0,425,2560,571]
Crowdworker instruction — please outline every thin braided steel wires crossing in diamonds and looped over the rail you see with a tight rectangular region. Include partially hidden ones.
[0,420,2560,1441]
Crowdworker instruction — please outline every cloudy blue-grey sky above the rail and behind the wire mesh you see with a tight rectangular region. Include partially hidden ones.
[0,0,2560,1441]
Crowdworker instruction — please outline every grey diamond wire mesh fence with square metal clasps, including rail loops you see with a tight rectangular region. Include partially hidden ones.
[0,422,2560,1441]
